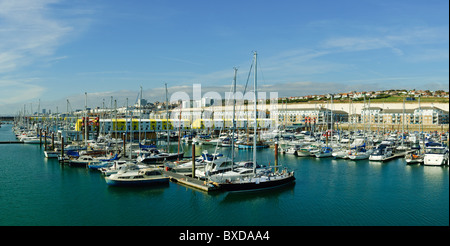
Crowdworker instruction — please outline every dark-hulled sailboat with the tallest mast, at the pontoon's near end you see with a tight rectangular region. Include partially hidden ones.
[212,52,295,191]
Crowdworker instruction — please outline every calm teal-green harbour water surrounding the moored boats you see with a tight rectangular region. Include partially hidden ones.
[0,125,449,226]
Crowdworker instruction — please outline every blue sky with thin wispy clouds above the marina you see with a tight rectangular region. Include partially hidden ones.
[0,0,449,114]
